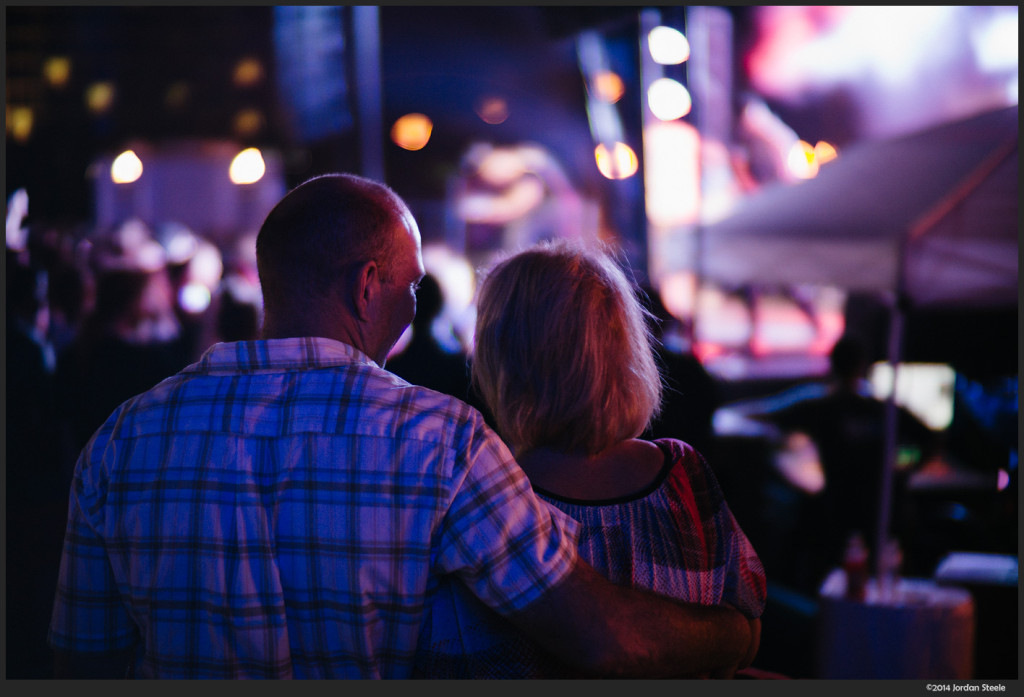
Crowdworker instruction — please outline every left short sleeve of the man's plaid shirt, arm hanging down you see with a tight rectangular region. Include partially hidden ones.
[49,421,138,653]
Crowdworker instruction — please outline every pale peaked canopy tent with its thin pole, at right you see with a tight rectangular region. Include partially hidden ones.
[698,105,1020,573]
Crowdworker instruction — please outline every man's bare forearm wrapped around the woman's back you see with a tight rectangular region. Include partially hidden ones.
[509,560,760,678]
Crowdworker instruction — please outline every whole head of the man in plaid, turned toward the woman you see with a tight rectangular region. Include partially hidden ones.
[256,174,424,364]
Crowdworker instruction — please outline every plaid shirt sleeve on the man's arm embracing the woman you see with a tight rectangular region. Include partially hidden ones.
[428,415,578,615]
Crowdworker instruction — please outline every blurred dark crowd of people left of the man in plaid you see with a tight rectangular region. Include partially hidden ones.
[6,197,261,678]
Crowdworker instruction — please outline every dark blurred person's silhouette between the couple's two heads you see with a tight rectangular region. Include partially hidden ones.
[387,273,469,401]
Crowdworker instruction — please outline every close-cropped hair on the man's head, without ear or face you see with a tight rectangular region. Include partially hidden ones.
[256,174,406,329]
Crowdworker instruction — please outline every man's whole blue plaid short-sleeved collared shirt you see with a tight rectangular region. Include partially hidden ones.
[49,338,577,679]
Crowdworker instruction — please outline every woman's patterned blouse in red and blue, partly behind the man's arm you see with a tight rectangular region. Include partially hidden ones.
[414,438,767,679]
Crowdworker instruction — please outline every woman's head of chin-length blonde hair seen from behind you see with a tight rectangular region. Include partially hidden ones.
[473,242,662,454]
